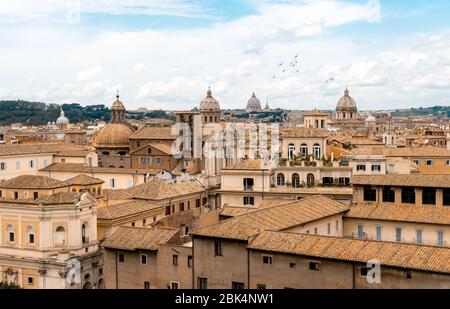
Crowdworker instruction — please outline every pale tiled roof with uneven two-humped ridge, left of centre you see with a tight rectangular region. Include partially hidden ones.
[128,180,205,200]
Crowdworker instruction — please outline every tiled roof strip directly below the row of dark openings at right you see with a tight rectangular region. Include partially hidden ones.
[345,204,450,225]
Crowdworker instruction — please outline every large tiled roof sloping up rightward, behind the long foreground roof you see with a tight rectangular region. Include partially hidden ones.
[191,196,349,240]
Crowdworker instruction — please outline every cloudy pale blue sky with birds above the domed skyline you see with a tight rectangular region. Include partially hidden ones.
[0,0,450,110]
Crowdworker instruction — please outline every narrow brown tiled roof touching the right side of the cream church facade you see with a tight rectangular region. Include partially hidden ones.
[97,201,161,220]
